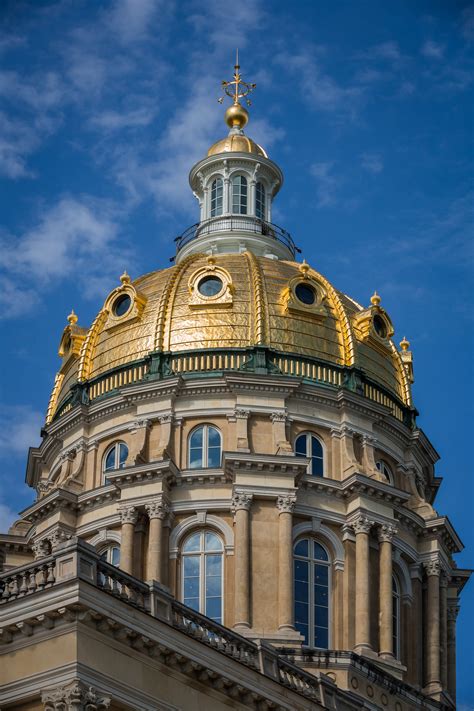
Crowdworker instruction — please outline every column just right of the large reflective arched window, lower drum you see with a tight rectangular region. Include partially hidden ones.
[232,491,253,628]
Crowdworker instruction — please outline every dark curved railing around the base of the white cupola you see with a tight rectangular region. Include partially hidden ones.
[170,215,301,261]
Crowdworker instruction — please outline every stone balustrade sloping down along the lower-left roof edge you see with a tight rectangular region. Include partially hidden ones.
[0,538,328,700]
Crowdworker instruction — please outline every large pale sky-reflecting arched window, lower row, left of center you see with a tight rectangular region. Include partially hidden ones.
[182,530,224,624]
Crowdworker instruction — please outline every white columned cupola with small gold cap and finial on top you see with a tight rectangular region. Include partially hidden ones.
[176,55,297,262]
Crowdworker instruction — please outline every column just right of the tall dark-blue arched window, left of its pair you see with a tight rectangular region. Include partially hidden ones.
[352,516,374,654]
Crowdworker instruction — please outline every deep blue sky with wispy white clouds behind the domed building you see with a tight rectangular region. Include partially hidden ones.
[0,0,474,711]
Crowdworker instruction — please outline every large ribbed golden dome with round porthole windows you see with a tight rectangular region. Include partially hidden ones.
[48,252,411,421]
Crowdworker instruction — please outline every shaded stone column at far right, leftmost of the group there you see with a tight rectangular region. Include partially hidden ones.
[423,560,441,694]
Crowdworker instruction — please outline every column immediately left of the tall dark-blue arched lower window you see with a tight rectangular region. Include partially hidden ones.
[277,494,296,631]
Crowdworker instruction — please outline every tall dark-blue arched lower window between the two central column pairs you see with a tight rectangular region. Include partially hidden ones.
[294,538,330,649]
